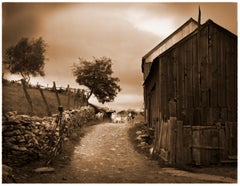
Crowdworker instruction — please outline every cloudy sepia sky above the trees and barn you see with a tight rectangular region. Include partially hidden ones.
[2,2,238,110]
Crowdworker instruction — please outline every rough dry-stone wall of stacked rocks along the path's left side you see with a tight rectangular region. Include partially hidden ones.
[2,106,95,166]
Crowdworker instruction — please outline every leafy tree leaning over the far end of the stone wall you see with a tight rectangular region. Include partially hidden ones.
[73,57,121,104]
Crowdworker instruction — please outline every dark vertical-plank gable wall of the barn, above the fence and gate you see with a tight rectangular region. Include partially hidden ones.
[158,22,237,125]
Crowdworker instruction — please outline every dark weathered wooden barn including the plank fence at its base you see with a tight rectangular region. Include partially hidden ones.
[142,18,237,165]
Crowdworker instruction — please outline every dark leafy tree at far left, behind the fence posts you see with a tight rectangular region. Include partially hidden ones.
[3,37,46,83]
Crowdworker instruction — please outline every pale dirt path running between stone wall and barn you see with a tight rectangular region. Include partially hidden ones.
[14,123,236,183]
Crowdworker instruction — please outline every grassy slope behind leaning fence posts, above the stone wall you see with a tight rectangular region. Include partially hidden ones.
[2,83,84,117]
